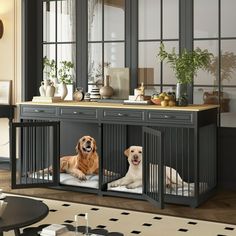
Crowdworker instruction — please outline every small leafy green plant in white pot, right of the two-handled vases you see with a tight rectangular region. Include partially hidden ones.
[57,61,74,100]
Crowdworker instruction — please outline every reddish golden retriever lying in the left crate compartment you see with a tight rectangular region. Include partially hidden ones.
[39,136,99,180]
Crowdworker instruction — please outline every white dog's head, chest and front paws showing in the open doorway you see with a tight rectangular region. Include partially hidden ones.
[110,146,143,188]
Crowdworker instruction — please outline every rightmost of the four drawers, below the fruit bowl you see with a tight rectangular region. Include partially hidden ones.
[147,111,193,124]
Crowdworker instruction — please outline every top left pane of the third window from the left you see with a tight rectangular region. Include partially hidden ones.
[139,0,161,40]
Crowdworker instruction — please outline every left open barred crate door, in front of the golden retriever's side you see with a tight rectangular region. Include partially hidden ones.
[11,122,60,188]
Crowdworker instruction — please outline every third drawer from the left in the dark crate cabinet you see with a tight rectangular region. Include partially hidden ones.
[103,109,145,122]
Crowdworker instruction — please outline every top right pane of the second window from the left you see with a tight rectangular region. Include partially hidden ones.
[104,0,125,40]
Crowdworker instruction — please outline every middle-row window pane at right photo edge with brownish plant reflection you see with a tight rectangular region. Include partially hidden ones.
[221,39,236,85]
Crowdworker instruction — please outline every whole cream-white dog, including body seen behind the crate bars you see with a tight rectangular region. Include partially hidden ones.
[110,146,188,189]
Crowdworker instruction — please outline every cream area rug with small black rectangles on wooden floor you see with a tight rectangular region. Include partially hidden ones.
[4,194,236,236]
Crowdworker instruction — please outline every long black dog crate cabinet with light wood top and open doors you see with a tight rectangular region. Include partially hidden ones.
[11,102,218,207]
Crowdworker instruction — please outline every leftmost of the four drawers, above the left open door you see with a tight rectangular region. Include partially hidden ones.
[21,106,57,118]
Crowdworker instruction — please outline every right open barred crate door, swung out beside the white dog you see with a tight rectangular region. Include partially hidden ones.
[143,127,164,208]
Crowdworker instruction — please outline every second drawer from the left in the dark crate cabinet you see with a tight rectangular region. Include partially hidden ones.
[59,107,98,120]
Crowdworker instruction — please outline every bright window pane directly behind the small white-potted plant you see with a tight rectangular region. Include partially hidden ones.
[57,44,76,82]
